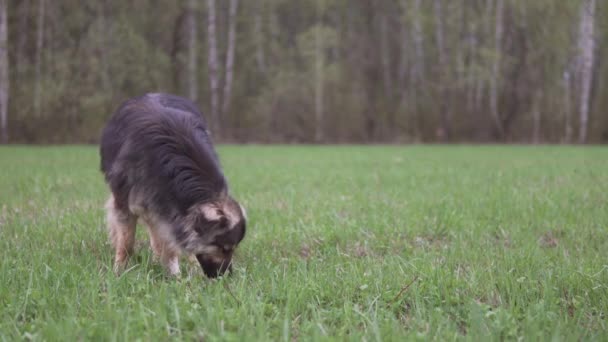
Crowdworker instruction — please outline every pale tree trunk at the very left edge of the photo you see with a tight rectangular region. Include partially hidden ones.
[0,0,9,143]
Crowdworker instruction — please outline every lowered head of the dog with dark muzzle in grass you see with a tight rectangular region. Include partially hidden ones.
[191,196,247,278]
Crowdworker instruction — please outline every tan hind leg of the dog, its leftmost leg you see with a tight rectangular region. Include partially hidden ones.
[106,196,137,274]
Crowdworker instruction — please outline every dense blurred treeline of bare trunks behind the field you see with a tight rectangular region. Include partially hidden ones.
[0,0,608,143]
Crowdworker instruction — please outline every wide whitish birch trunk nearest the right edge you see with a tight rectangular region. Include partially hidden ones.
[578,0,595,144]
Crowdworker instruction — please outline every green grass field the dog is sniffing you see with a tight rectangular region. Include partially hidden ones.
[0,146,608,341]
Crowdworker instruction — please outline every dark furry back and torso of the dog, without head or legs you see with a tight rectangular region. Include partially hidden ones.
[101,94,227,215]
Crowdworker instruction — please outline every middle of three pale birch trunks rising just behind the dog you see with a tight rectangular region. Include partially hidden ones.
[207,0,221,137]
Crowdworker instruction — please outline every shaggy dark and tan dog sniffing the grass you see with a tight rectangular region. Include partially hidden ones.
[100,93,246,278]
